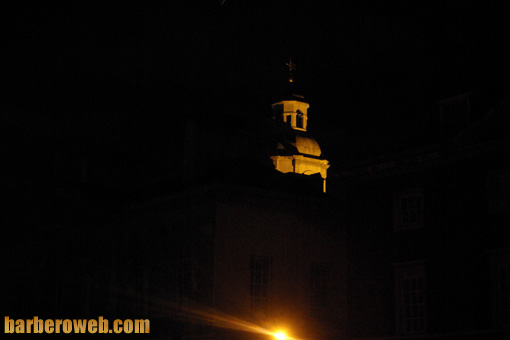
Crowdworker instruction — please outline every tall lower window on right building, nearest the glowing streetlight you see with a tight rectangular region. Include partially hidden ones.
[395,262,426,334]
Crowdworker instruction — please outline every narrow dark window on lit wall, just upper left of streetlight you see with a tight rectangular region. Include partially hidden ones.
[250,256,273,311]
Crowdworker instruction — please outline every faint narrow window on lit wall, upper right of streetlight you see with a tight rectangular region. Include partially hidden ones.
[310,264,330,317]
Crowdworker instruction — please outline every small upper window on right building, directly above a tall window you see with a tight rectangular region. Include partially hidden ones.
[393,189,424,230]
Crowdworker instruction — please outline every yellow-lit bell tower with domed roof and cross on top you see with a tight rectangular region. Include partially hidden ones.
[271,61,329,192]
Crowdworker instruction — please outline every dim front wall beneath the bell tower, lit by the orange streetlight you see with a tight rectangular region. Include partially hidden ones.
[214,187,347,339]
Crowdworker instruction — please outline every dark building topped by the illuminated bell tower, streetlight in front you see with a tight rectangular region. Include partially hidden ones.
[3,65,347,339]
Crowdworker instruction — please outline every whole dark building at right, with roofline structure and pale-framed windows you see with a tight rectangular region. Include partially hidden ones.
[336,95,510,339]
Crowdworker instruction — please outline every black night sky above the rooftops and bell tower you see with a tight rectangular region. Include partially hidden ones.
[2,0,510,189]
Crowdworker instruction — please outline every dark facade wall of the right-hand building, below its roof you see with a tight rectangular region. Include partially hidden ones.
[345,139,510,339]
